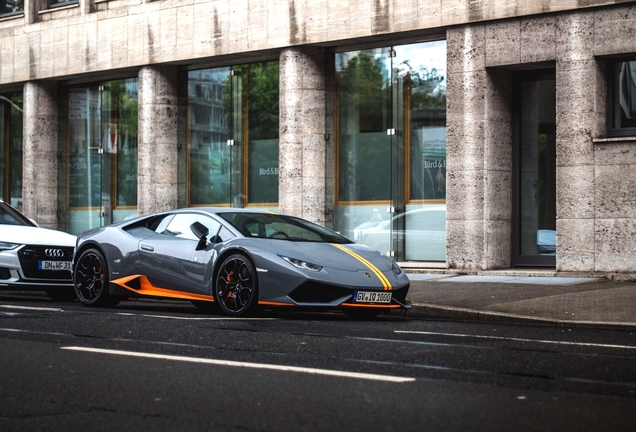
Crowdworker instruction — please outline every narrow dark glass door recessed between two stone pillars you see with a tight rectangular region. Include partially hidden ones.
[513,70,556,266]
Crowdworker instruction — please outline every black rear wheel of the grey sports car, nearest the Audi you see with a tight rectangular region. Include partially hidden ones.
[73,249,120,307]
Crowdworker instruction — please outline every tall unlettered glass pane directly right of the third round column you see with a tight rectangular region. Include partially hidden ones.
[335,47,396,254]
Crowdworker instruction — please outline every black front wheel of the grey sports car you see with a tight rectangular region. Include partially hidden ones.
[214,254,258,316]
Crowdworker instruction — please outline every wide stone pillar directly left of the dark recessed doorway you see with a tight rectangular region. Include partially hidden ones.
[446,24,512,270]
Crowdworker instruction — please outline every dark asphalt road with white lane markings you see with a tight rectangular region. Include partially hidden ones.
[0,291,636,432]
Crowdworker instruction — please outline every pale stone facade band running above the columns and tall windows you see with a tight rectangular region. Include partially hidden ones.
[0,0,625,83]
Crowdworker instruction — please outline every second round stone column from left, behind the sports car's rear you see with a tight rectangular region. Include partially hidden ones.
[137,66,179,215]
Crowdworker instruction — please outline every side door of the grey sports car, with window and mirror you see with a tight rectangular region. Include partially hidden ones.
[139,213,221,294]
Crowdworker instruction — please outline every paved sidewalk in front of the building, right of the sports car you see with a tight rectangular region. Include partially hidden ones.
[407,273,636,331]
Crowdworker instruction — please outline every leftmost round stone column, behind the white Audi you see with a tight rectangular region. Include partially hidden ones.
[22,81,58,229]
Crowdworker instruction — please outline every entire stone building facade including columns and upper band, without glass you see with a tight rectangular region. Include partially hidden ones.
[0,0,636,273]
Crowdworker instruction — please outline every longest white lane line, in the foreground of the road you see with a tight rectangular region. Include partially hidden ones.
[61,346,415,383]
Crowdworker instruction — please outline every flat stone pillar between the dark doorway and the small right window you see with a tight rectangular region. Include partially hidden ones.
[556,11,600,271]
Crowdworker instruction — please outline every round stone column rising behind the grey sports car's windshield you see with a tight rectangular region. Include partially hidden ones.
[278,47,332,225]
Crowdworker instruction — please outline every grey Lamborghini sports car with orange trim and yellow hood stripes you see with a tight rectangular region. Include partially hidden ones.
[73,208,410,318]
